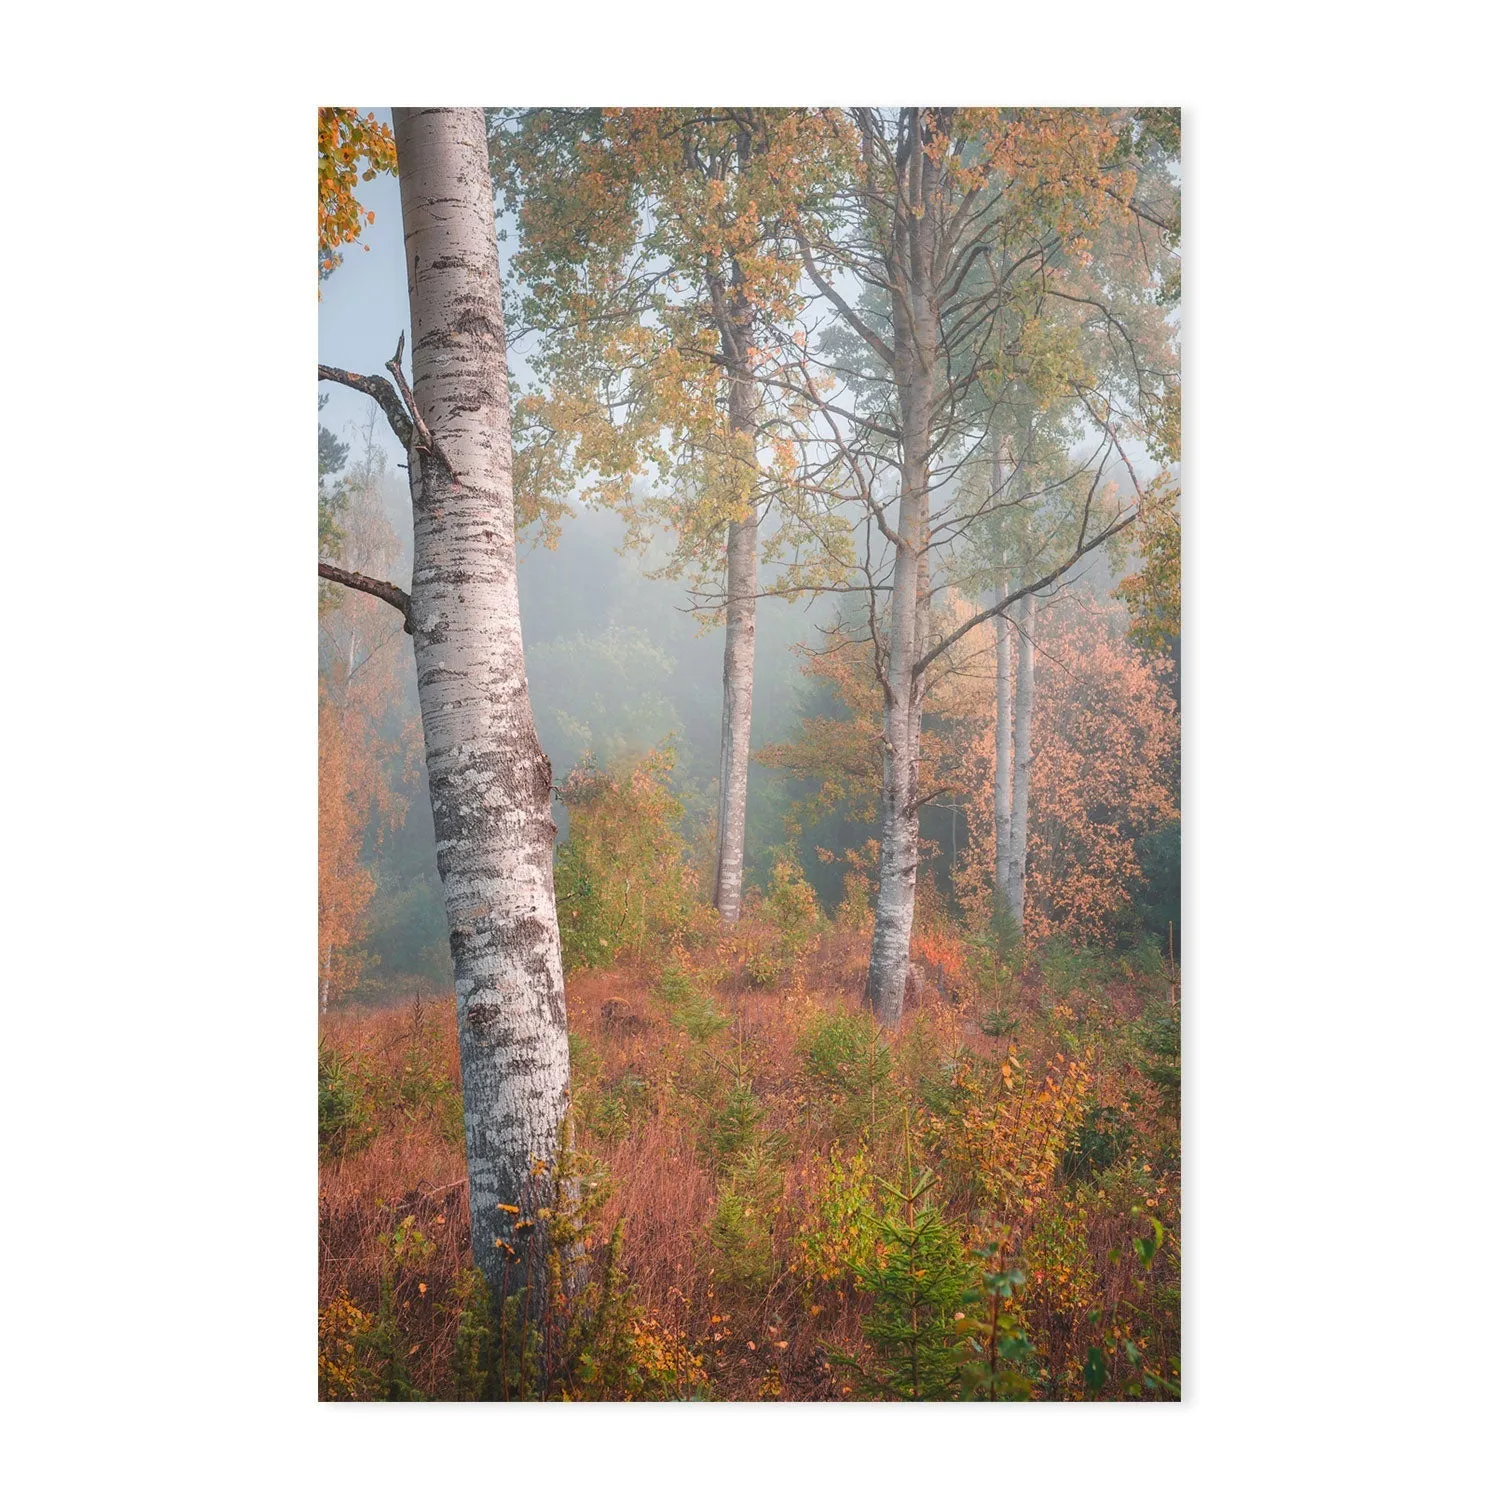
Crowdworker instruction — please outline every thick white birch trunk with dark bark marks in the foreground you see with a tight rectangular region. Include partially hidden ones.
[393,110,569,1305]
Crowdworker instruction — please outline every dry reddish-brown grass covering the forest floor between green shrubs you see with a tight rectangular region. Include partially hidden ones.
[320,924,1175,1400]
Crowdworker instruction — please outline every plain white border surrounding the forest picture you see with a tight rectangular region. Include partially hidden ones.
[5,3,1496,1497]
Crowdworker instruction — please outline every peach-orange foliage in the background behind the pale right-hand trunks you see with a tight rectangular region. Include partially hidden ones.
[761,597,1179,942]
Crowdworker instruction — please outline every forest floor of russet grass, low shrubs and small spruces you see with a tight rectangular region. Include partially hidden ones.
[318,921,1181,1401]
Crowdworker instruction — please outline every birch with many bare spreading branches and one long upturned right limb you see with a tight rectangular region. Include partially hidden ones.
[797,107,1161,1023]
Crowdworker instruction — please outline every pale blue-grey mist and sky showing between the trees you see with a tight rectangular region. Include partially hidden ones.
[318,110,1158,990]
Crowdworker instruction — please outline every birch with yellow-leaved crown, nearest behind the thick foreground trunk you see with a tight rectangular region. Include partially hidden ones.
[492,107,840,923]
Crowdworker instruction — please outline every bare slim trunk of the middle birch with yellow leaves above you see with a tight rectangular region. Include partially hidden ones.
[714,364,761,923]
